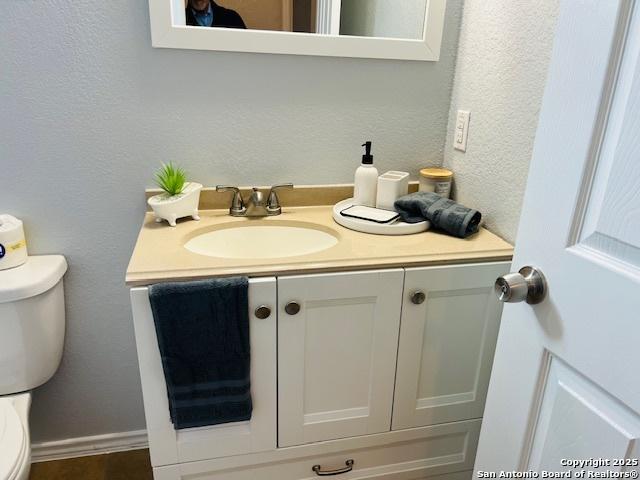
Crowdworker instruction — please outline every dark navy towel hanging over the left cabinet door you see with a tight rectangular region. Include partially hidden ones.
[149,278,252,429]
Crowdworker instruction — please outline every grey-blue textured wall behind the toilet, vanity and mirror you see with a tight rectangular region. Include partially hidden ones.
[0,0,461,442]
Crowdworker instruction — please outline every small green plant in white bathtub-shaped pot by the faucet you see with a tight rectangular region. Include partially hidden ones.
[147,163,202,227]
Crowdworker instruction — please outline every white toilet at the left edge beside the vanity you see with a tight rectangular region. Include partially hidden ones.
[0,255,67,480]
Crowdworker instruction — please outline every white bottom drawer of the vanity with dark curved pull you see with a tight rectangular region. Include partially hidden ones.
[154,420,480,480]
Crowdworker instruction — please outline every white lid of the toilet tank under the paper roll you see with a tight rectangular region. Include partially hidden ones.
[0,255,67,303]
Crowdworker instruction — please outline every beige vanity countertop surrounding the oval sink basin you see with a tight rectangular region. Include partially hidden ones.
[126,206,513,286]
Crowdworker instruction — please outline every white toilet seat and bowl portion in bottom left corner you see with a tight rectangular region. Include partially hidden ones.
[0,393,31,480]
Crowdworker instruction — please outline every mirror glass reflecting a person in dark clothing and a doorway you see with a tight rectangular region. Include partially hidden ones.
[185,0,427,40]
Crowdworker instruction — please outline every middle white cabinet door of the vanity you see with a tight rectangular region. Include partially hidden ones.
[278,269,403,447]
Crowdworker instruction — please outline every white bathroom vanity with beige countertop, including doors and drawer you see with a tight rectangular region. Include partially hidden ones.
[127,192,512,480]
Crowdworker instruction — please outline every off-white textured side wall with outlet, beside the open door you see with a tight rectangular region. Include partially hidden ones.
[445,0,558,242]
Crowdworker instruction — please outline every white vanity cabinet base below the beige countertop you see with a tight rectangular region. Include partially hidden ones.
[131,262,509,480]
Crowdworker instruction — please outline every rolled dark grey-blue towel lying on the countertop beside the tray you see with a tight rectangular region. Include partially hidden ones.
[394,192,482,238]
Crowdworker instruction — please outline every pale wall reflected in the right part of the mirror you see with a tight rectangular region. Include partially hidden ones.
[340,0,427,38]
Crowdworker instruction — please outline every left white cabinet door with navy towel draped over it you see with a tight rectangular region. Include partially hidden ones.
[131,277,277,467]
